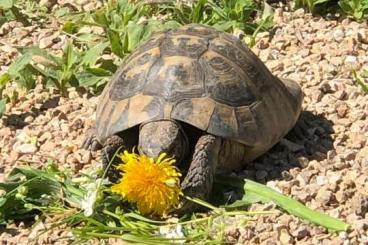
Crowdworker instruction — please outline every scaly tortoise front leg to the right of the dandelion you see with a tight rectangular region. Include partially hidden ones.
[179,134,221,212]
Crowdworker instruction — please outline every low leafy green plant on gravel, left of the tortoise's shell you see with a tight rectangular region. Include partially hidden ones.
[3,42,116,95]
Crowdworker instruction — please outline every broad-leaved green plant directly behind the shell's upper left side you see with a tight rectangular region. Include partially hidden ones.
[64,0,179,59]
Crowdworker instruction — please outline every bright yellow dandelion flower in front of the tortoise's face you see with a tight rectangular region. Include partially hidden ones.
[112,151,182,215]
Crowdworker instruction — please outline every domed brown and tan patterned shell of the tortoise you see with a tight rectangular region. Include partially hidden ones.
[96,24,301,153]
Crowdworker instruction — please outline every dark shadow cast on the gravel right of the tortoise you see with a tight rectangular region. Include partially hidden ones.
[242,111,334,183]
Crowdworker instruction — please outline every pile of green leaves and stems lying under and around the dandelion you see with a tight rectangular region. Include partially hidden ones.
[0,161,348,244]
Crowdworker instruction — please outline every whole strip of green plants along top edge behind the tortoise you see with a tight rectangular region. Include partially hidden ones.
[64,0,272,58]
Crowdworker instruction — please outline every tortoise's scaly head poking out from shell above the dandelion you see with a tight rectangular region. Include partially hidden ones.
[138,120,189,164]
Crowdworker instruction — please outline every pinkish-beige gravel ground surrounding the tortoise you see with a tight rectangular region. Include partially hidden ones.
[0,1,368,245]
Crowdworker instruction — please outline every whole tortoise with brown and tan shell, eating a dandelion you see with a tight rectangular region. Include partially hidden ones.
[83,24,303,212]
